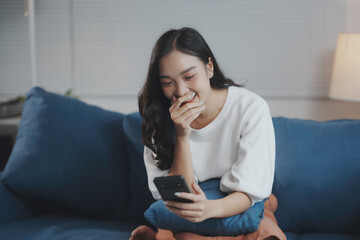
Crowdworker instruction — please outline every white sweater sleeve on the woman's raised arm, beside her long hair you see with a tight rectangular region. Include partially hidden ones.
[144,146,169,200]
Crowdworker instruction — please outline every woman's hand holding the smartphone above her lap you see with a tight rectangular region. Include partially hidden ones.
[164,183,219,223]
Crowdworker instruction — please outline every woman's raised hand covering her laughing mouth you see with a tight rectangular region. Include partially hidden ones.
[169,93,205,137]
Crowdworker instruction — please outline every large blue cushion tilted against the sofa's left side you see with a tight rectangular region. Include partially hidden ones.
[1,87,128,219]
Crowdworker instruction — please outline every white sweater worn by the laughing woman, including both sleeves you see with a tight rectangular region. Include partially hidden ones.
[144,87,275,205]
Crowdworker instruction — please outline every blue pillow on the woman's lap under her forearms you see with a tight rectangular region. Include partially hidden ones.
[145,179,265,236]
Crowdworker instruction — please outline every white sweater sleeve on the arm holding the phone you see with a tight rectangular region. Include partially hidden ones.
[220,100,275,206]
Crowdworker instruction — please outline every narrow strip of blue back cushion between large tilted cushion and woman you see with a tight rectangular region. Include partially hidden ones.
[123,112,154,224]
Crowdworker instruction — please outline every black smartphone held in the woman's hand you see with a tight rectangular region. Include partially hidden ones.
[154,175,192,203]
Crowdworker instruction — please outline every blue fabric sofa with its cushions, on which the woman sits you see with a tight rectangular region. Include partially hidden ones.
[0,88,360,240]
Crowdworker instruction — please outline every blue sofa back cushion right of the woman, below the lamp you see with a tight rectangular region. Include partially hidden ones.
[273,118,360,233]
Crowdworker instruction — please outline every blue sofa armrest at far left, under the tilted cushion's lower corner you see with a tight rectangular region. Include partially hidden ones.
[0,176,34,225]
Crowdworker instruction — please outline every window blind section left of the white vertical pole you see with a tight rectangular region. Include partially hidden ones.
[0,0,31,98]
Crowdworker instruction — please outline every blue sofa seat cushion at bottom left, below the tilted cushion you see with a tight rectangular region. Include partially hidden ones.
[0,215,136,240]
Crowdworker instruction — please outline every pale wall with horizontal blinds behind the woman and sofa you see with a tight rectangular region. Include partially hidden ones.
[0,0,360,120]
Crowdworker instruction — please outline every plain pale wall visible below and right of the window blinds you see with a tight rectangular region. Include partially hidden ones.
[79,0,360,121]
